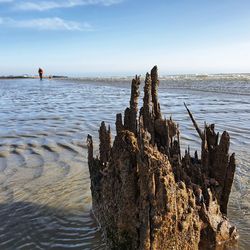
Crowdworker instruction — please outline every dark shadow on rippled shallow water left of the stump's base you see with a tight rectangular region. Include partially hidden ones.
[0,202,104,249]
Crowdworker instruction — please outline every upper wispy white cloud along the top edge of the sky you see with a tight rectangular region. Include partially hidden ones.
[13,0,123,11]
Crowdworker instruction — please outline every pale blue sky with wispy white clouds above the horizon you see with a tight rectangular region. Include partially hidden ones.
[0,0,250,76]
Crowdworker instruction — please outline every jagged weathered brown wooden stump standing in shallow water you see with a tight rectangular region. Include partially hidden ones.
[87,66,238,250]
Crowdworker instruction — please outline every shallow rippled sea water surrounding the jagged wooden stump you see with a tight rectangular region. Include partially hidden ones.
[0,77,250,249]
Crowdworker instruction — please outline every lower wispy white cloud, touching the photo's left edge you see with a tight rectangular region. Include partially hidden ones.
[0,17,93,31]
